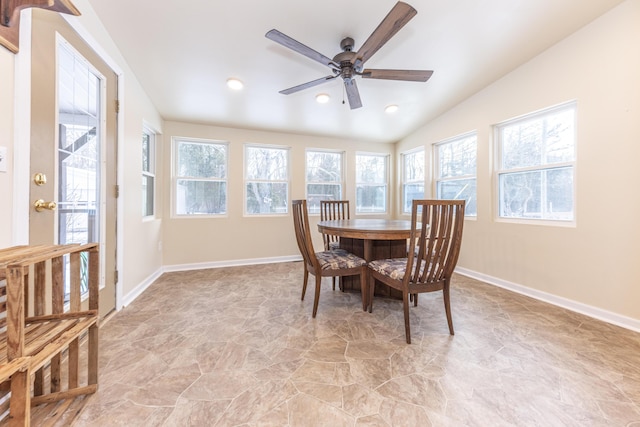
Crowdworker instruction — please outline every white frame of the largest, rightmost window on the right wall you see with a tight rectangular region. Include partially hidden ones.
[494,100,578,227]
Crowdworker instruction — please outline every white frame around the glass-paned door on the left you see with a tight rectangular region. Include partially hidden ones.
[12,9,125,311]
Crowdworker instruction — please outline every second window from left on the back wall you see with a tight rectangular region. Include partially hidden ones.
[244,144,289,215]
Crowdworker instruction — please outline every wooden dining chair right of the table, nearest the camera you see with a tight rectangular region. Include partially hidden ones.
[368,200,465,344]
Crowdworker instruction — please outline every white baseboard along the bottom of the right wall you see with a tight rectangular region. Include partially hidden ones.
[455,267,640,332]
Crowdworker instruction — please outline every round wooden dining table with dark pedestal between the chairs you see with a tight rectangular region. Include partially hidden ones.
[318,218,411,298]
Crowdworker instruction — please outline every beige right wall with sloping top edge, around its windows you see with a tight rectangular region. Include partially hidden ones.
[397,1,640,320]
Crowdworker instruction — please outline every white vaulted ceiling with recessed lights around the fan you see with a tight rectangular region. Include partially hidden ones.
[89,0,622,142]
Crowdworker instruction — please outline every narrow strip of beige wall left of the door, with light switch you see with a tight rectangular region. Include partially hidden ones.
[0,48,14,248]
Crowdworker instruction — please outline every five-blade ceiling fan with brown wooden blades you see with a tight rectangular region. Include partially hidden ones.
[265,1,433,110]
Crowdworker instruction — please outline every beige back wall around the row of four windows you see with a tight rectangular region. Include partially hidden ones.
[163,122,394,266]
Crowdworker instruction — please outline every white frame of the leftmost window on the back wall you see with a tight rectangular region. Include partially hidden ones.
[171,136,229,219]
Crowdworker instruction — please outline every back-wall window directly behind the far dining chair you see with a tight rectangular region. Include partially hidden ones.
[306,150,344,213]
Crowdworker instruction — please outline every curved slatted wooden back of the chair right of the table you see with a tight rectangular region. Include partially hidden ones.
[406,200,465,284]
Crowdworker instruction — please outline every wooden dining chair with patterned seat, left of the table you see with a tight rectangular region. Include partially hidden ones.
[292,200,367,317]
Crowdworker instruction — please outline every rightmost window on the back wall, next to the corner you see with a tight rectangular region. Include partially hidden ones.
[356,154,388,213]
